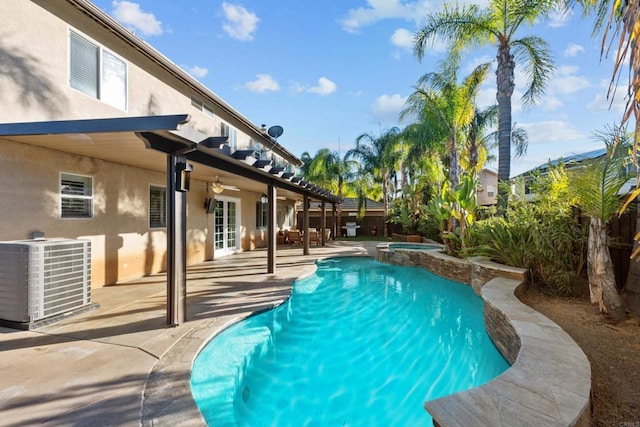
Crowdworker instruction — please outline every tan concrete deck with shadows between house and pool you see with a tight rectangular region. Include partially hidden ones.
[0,242,592,426]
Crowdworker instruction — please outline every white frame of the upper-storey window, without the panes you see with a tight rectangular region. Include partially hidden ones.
[67,27,129,112]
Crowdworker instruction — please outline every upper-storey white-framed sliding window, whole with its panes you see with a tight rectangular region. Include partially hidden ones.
[69,31,127,110]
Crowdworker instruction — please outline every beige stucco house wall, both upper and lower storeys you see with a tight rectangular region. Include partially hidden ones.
[0,0,302,286]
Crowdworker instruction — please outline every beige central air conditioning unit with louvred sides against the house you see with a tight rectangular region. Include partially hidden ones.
[0,239,91,323]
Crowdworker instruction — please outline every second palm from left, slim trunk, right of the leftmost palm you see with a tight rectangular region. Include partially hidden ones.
[345,127,400,236]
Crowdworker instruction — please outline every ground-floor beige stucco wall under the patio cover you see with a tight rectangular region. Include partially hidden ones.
[0,139,282,286]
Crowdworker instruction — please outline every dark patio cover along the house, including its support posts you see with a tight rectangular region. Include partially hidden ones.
[0,114,340,326]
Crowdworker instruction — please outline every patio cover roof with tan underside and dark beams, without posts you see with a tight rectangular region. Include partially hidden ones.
[0,114,339,203]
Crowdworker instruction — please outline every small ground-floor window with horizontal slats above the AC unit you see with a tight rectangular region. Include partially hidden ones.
[60,173,93,218]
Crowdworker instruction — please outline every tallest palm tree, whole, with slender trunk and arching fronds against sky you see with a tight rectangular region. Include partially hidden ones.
[413,0,555,208]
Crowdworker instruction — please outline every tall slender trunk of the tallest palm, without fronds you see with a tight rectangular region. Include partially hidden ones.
[496,42,516,212]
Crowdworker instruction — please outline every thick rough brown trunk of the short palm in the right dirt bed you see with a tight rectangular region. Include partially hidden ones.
[587,217,625,323]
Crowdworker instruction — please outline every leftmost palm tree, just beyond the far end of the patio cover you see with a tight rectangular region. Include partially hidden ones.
[305,148,358,237]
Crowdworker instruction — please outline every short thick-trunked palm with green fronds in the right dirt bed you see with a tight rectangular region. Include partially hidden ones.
[571,128,629,322]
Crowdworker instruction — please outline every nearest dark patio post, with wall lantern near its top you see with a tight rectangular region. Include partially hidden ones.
[166,154,189,326]
